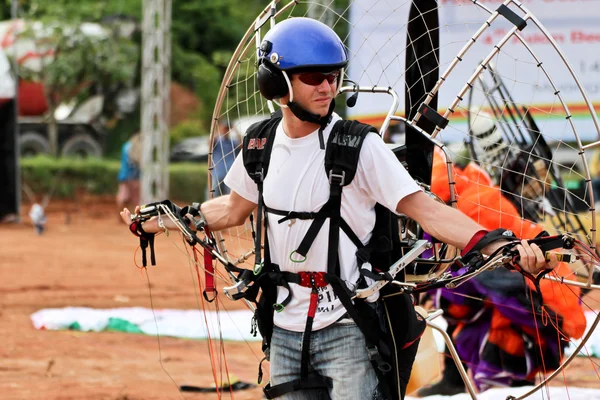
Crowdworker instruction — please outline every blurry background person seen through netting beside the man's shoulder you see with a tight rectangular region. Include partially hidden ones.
[211,120,239,196]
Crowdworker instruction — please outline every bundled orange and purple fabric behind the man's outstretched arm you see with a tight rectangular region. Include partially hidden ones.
[417,147,586,397]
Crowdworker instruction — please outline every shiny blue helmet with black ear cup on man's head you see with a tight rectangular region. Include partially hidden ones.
[257,18,348,100]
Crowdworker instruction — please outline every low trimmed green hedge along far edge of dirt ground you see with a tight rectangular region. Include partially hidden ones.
[21,156,207,203]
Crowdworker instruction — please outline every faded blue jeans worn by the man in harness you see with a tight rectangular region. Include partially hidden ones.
[270,322,379,400]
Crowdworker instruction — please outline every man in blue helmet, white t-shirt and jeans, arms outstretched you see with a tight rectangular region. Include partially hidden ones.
[121,18,556,400]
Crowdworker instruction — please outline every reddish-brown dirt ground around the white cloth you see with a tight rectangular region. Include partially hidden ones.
[0,198,600,400]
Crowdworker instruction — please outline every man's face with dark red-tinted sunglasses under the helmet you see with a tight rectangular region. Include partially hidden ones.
[291,71,340,117]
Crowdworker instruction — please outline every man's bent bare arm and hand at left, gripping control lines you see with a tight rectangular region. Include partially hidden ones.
[120,191,256,233]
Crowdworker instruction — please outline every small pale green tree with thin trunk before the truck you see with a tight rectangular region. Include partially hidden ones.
[9,0,139,156]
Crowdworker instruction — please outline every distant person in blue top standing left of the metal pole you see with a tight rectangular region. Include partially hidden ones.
[116,132,142,209]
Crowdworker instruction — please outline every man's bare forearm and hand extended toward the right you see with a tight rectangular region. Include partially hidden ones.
[396,192,558,275]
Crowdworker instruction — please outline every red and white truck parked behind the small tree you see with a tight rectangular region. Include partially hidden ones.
[0,20,137,157]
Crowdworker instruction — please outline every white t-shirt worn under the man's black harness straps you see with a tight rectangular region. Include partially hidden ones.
[225,114,420,332]
